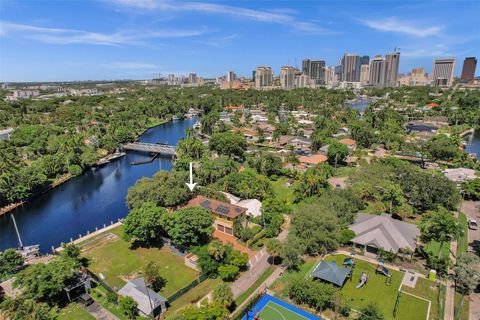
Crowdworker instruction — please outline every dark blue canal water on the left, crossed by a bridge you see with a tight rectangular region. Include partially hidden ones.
[0,119,196,252]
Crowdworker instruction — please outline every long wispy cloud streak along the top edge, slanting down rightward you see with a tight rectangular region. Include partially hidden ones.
[110,0,335,34]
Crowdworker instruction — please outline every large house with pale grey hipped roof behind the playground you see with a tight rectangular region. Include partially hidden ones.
[349,213,420,252]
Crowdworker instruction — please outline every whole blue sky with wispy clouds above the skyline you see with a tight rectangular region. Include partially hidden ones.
[0,0,480,81]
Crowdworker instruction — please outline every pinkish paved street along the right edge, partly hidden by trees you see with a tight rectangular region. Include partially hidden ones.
[462,201,480,320]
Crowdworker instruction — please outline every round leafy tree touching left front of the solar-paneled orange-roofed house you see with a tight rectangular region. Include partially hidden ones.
[162,207,214,246]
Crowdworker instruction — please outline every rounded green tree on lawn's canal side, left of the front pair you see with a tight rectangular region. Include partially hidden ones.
[123,202,168,243]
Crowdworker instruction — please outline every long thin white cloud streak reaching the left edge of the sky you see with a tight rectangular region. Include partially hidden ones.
[0,21,209,46]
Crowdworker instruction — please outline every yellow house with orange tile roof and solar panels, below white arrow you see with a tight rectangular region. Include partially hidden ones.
[186,196,247,236]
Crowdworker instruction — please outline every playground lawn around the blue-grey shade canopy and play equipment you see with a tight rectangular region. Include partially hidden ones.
[325,255,428,320]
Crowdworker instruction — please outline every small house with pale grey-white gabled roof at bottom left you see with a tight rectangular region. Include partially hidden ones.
[118,278,167,316]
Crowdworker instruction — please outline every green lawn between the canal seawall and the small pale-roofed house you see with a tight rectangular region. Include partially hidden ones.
[82,226,199,298]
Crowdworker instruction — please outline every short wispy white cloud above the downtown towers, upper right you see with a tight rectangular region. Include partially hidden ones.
[360,17,444,37]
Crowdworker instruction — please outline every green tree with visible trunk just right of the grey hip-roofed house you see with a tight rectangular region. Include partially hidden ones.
[420,207,463,259]
